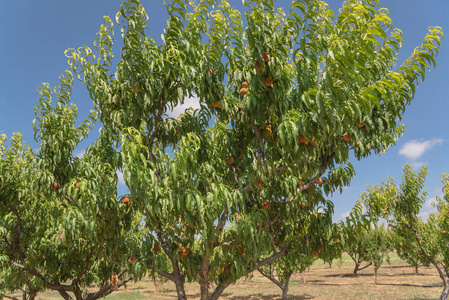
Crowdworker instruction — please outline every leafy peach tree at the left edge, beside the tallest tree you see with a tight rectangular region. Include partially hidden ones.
[0,71,140,299]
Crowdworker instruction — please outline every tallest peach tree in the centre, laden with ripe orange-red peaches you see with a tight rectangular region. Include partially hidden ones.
[66,0,442,299]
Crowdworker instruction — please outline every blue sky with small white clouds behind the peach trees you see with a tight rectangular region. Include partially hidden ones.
[0,0,449,220]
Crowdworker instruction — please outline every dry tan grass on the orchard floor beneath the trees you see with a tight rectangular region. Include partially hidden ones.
[7,256,442,300]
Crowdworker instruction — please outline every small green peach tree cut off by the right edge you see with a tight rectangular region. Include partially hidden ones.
[363,164,449,300]
